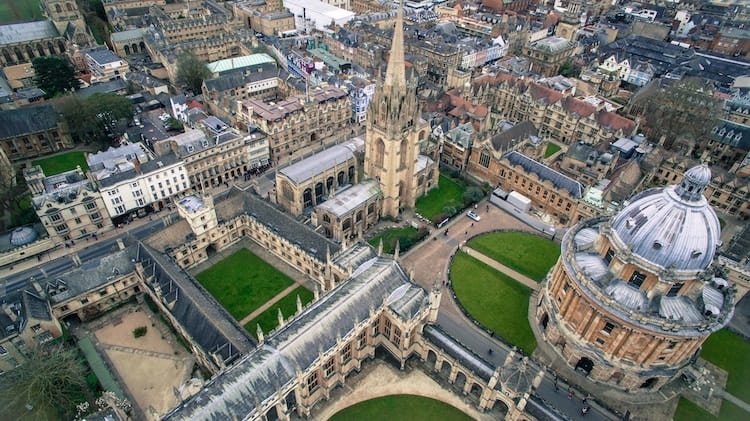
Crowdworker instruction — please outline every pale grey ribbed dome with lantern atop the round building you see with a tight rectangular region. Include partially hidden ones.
[612,165,721,273]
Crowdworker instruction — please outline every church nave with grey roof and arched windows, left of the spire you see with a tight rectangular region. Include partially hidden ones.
[276,138,365,215]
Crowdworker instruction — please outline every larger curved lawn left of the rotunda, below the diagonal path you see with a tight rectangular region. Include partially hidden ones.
[450,252,536,354]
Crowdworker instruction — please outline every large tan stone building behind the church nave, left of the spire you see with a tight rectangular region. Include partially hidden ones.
[237,86,352,165]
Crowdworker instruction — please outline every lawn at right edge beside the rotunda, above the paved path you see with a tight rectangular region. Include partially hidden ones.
[701,329,750,400]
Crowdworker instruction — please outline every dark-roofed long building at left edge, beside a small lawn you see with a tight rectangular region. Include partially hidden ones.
[0,104,73,161]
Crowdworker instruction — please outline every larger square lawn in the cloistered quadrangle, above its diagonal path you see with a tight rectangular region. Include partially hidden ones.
[196,249,294,320]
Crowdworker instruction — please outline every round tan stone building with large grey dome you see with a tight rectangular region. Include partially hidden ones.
[536,165,735,391]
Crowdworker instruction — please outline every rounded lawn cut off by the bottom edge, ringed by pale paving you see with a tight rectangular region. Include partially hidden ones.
[329,395,472,421]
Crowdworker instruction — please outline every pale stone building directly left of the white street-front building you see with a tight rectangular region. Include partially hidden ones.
[23,165,112,244]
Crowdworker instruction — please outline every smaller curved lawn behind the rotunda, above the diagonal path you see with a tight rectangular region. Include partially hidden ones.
[469,232,560,282]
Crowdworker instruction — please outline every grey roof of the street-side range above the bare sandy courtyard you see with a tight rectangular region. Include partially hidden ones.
[45,246,137,303]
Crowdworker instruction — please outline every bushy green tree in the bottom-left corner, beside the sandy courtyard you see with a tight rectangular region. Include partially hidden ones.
[0,343,86,419]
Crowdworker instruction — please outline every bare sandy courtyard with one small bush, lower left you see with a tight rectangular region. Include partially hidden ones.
[93,306,195,420]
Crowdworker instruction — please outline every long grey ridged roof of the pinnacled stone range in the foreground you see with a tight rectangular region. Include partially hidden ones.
[164,257,427,420]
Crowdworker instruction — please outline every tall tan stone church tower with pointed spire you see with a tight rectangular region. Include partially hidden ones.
[365,6,437,217]
